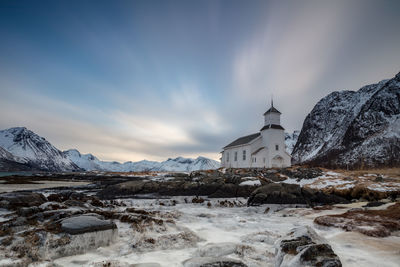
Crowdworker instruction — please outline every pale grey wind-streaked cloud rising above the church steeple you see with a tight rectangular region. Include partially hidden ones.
[228,1,366,130]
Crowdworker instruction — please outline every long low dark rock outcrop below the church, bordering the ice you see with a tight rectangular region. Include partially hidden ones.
[247,183,348,206]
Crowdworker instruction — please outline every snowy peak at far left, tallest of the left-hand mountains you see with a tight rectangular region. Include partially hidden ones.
[0,127,79,171]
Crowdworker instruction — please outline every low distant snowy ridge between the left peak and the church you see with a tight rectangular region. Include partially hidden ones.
[63,149,219,172]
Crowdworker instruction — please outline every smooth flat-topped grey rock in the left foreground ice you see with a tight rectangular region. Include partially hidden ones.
[61,215,117,235]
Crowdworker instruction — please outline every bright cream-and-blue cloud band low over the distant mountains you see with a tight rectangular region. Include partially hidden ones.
[0,78,223,161]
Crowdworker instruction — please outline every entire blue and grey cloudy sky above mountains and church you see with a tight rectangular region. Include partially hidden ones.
[0,0,400,161]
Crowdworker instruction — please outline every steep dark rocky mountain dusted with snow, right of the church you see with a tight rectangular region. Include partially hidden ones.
[292,70,400,168]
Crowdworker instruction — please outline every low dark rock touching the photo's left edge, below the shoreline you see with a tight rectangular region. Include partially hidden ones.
[0,192,47,210]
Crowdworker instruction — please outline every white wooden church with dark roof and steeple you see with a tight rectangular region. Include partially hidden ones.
[221,101,291,168]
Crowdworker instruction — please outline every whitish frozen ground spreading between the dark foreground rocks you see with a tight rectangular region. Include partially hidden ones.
[33,197,400,267]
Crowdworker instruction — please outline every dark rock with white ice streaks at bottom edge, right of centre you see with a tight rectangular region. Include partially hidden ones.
[275,226,342,267]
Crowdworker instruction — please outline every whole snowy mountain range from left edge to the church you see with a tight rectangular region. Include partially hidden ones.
[0,127,219,172]
